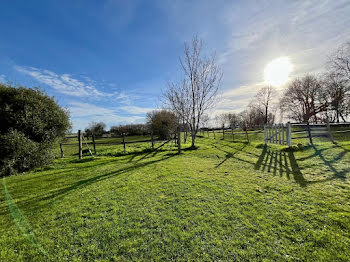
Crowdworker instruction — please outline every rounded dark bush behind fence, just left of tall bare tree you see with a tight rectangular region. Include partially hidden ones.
[147,109,178,139]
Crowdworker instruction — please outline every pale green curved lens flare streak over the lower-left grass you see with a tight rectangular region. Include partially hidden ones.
[2,178,48,256]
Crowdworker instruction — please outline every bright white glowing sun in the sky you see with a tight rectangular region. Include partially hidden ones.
[264,57,293,87]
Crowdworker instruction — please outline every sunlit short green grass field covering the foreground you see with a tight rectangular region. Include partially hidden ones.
[0,134,350,261]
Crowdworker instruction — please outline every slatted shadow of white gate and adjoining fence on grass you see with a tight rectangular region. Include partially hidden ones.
[254,145,350,187]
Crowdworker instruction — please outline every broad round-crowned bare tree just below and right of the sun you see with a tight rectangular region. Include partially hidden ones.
[280,75,328,123]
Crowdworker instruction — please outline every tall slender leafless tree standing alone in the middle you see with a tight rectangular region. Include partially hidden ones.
[163,37,222,147]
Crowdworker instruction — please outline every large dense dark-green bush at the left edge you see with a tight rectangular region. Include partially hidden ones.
[0,84,71,175]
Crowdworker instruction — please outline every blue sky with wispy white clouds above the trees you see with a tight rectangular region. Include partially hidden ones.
[0,0,350,131]
